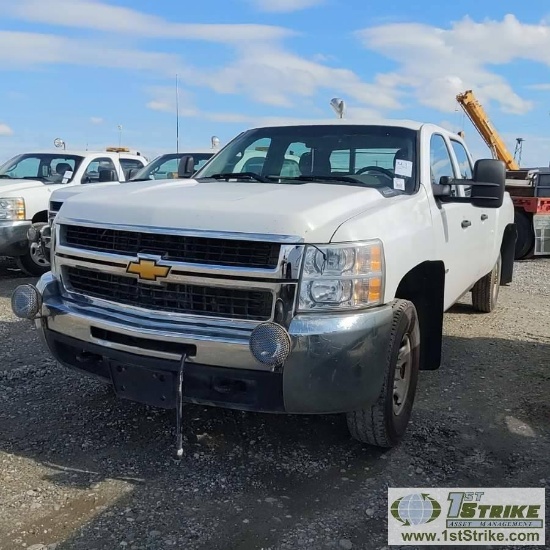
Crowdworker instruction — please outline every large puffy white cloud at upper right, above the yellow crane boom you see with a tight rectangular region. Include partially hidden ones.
[357,15,550,114]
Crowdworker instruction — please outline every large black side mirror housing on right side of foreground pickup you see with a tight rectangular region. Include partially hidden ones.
[470,159,506,208]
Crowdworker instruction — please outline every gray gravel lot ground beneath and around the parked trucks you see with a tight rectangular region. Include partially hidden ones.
[0,259,550,550]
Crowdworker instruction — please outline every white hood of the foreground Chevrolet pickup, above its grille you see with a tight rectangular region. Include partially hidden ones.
[58,180,391,243]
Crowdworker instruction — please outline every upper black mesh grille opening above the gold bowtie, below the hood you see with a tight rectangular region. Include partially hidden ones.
[62,225,281,269]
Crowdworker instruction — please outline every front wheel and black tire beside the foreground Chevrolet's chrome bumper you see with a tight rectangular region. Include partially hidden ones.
[347,300,420,448]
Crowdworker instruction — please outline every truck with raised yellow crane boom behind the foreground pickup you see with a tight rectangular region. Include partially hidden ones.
[457,90,550,260]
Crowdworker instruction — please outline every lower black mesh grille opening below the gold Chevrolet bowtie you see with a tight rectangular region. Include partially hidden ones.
[64,267,273,321]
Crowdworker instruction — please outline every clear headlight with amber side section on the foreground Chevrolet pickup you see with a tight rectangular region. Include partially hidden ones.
[298,240,385,311]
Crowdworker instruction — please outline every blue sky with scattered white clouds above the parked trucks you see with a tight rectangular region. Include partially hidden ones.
[0,0,550,166]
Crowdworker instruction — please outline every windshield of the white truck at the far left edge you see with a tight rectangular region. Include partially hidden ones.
[0,153,84,183]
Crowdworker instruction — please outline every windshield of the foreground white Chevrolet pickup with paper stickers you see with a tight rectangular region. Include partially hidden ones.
[195,124,417,193]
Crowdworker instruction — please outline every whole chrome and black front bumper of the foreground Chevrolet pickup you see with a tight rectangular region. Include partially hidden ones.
[31,273,392,413]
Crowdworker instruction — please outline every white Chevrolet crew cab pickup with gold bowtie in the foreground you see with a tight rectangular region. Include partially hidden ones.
[12,120,517,454]
